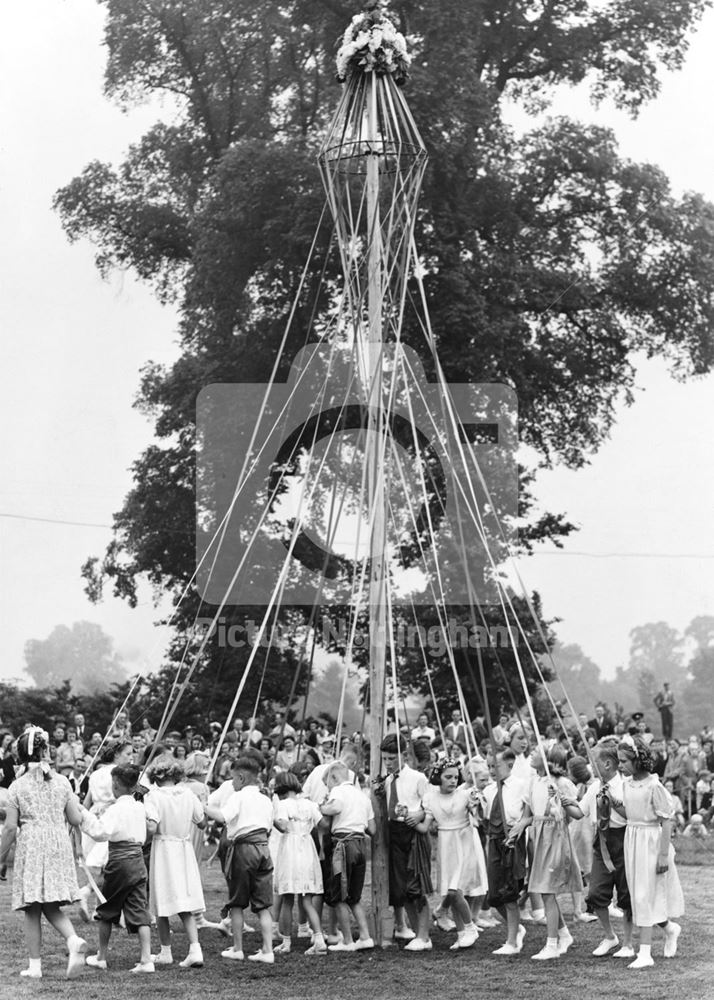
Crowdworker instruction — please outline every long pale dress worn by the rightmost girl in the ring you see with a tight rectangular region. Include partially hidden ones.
[622,774,684,927]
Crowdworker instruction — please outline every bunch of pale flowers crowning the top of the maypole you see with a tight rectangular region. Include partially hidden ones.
[337,0,411,87]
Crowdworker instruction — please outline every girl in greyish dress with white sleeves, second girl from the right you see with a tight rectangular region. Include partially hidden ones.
[511,746,583,961]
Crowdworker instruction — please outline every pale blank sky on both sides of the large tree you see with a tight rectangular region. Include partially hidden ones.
[0,0,714,679]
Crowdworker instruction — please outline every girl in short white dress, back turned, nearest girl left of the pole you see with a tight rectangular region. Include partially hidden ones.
[273,772,327,955]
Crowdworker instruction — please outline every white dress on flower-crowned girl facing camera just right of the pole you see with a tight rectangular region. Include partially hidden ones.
[424,785,488,896]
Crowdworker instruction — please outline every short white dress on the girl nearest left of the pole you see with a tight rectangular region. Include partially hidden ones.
[273,798,322,896]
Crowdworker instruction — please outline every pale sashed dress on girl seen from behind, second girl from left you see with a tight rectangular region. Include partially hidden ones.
[144,785,206,917]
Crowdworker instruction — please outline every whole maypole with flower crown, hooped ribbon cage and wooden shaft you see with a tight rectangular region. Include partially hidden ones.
[319,0,426,946]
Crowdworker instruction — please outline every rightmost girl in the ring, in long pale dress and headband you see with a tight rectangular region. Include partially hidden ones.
[613,736,684,969]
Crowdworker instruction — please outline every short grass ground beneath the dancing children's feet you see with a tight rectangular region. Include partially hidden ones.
[0,845,714,1000]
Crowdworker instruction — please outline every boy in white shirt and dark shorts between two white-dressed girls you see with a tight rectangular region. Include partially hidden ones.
[206,756,275,964]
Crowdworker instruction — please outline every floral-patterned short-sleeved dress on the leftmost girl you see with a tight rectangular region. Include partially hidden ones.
[8,765,79,910]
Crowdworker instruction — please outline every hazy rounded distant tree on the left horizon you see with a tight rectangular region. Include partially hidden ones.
[25,622,126,694]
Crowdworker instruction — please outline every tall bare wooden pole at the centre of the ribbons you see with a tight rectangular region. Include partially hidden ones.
[364,76,393,947]
